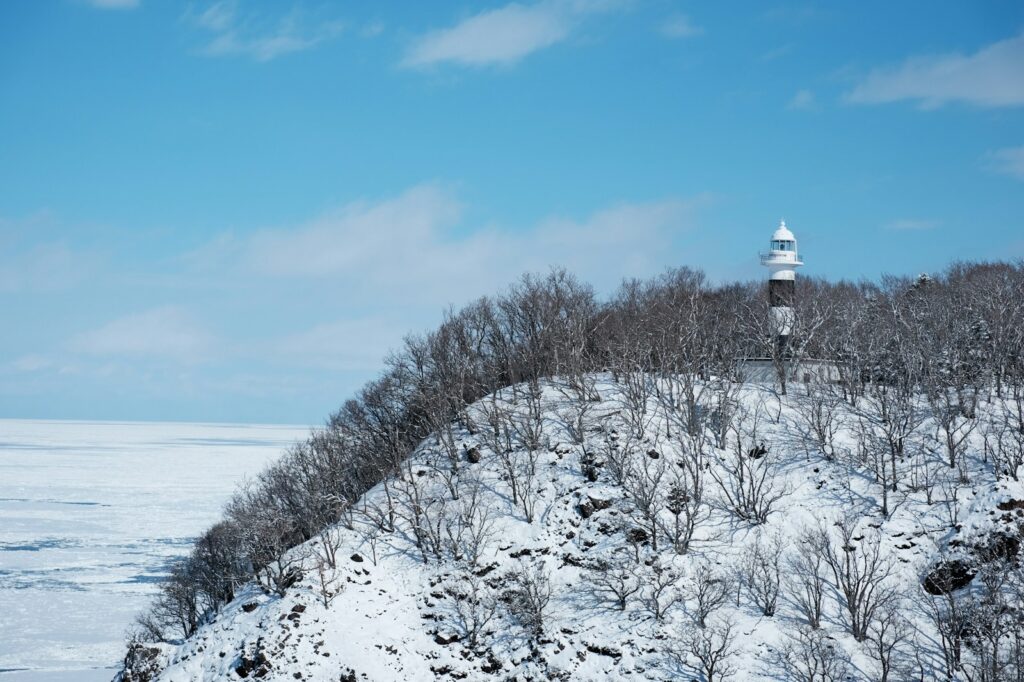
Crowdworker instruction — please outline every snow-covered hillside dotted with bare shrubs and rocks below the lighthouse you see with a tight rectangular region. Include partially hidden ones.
[124,377,1024,682]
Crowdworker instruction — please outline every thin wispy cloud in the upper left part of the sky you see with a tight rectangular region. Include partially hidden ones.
[188,0,344,61]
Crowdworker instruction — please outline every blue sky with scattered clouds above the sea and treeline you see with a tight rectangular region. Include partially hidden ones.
[0,0,1024,423]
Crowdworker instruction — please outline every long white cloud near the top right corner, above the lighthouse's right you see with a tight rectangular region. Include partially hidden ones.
[846,34,1024,109]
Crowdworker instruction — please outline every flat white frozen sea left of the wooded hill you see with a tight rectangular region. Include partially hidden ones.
[0,420,308,682]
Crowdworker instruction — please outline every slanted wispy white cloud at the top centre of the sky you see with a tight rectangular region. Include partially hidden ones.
[401,0,616,69]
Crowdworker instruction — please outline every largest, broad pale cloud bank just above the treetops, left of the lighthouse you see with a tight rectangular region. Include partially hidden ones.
[203,184,708,301]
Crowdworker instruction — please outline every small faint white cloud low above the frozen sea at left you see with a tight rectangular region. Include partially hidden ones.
[70,306,214,363]
